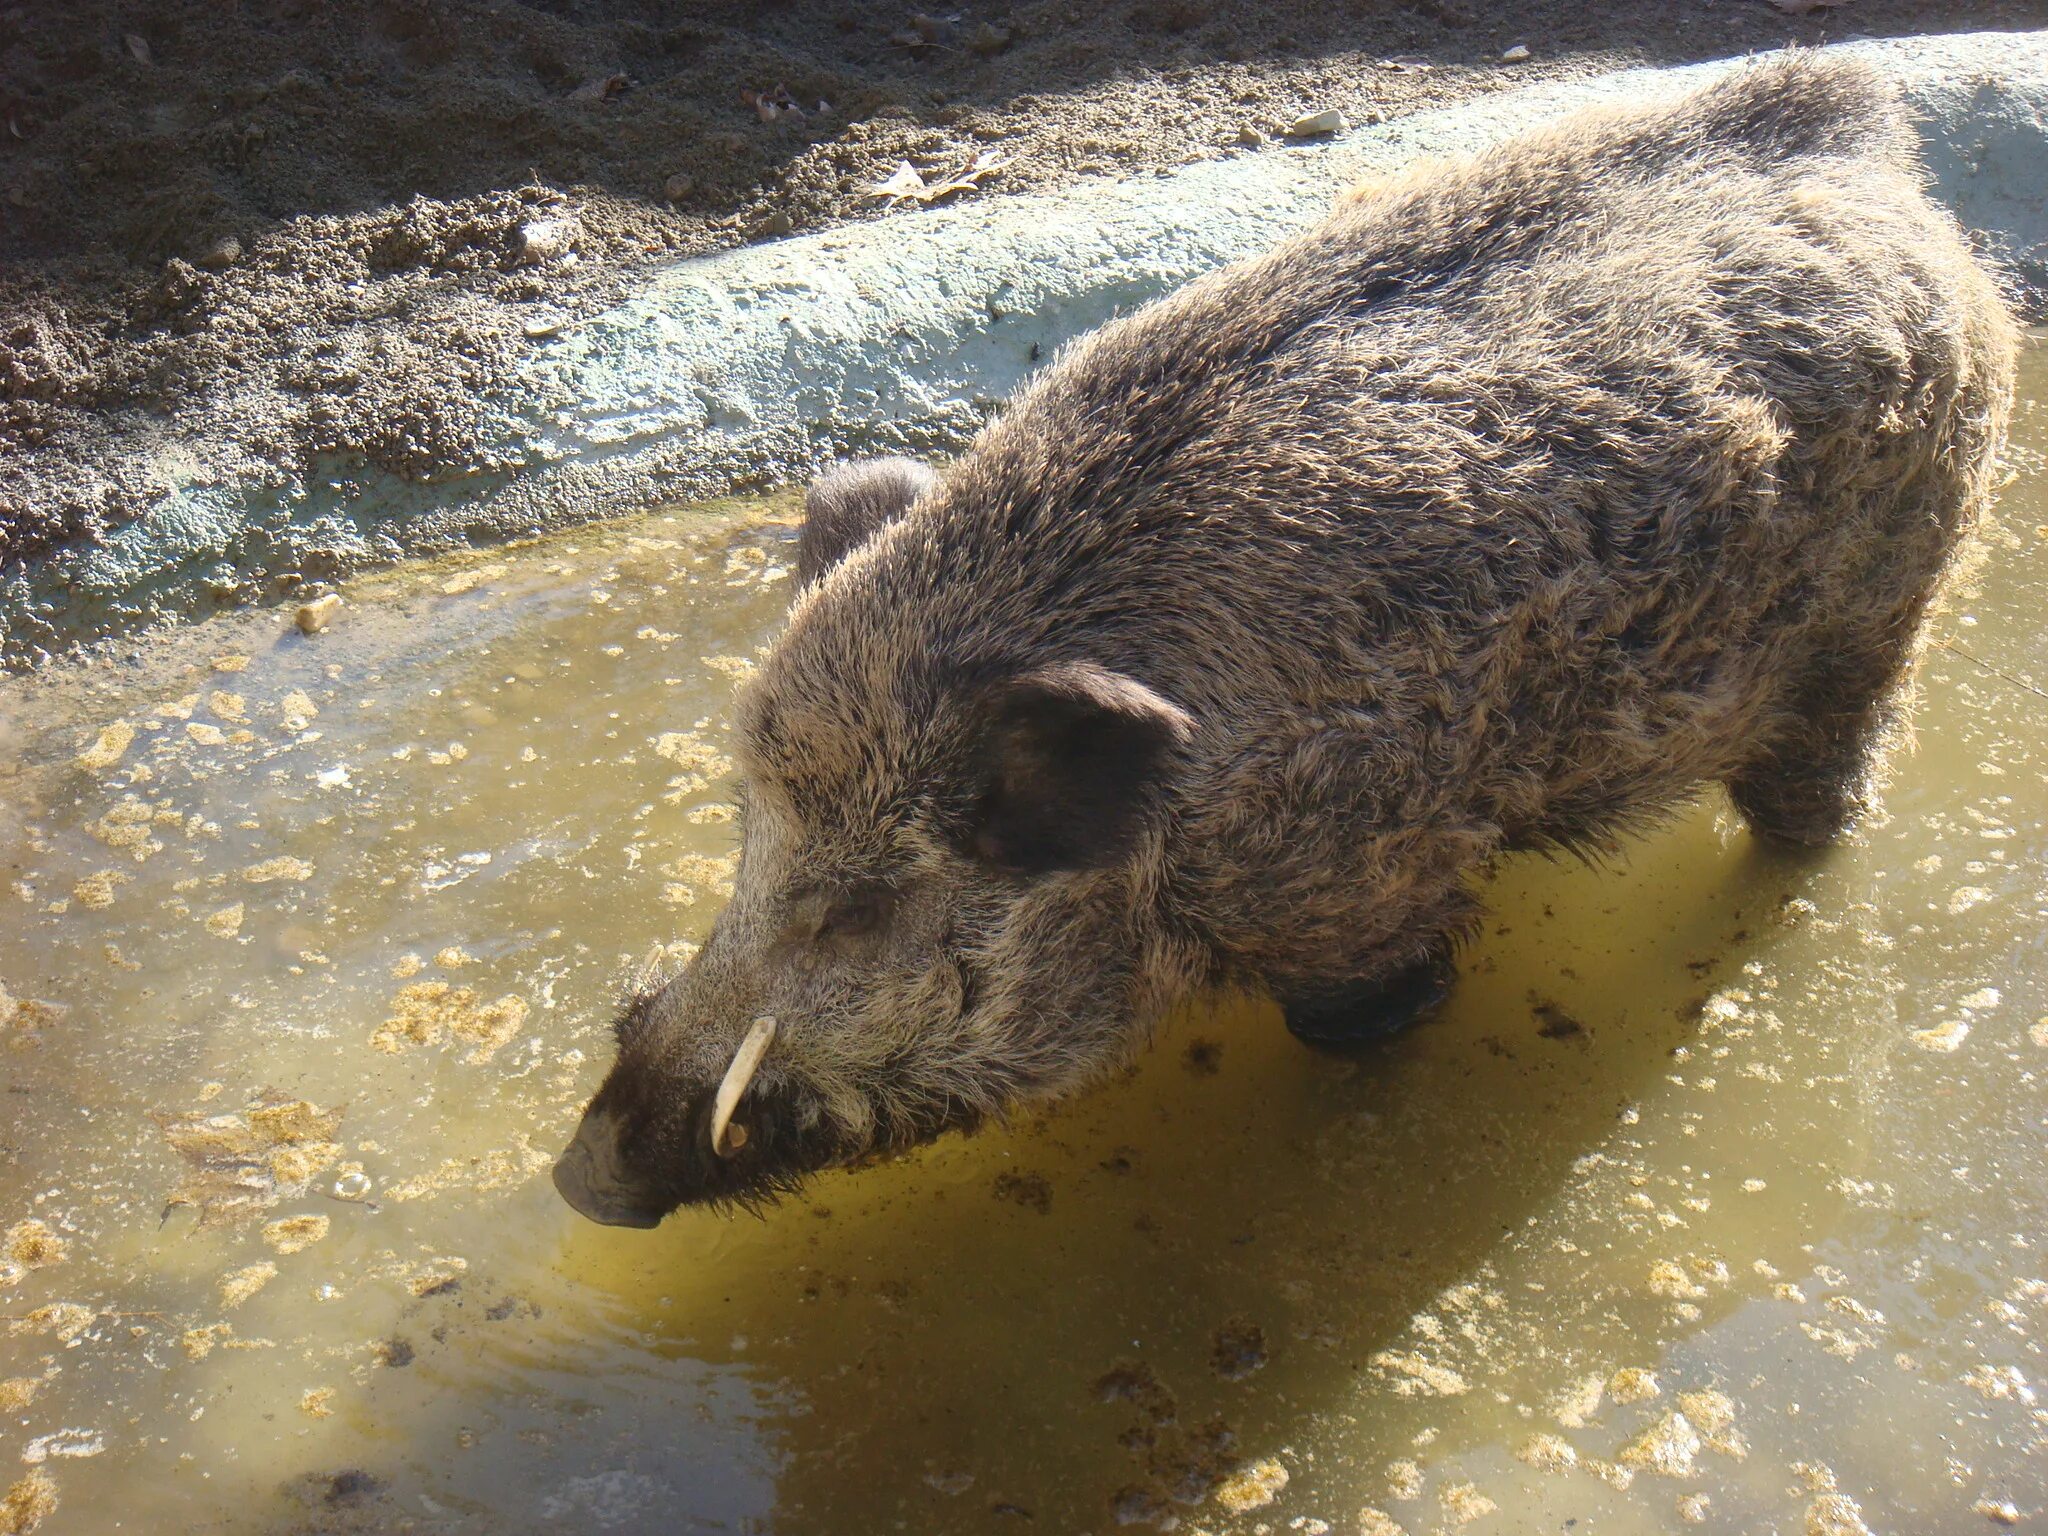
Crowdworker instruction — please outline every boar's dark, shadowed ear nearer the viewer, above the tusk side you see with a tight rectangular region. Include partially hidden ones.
[969,662,1194,874]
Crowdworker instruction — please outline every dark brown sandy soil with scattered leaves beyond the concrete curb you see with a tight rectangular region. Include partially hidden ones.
[0,0,2048,567]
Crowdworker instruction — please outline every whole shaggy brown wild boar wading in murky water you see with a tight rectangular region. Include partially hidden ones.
[555,55,2015,1227]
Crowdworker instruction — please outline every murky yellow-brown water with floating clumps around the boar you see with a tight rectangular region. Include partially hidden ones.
[0,352,2048,1536]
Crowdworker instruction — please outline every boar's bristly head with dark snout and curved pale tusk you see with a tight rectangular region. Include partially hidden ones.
[555,460,1194,1227]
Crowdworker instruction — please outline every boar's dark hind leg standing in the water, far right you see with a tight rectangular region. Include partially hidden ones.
[1729,618,1919,848]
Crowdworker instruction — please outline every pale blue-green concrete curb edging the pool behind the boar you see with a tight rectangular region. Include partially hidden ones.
[0,31,2048,664]
